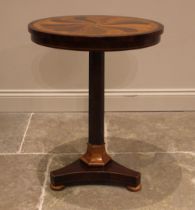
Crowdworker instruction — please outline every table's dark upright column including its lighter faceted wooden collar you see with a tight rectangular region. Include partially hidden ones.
[80,51,111,166]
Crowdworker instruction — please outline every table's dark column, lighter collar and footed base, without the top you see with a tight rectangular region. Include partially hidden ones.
[50,51,141,191]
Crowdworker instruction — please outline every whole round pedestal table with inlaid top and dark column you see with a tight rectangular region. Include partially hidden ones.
[28,15,164,191]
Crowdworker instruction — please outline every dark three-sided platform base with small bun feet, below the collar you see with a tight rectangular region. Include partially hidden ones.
[50,159,141,192]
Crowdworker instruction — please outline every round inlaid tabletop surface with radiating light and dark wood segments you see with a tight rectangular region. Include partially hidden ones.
[29,15,163,37]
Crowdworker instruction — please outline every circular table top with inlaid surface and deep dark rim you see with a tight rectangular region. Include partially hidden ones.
[28,15,164,51]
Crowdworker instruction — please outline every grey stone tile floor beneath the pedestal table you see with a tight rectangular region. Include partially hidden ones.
[0,112,195,210]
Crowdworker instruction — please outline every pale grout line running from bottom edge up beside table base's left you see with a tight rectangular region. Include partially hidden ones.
[37,157,53,210]
